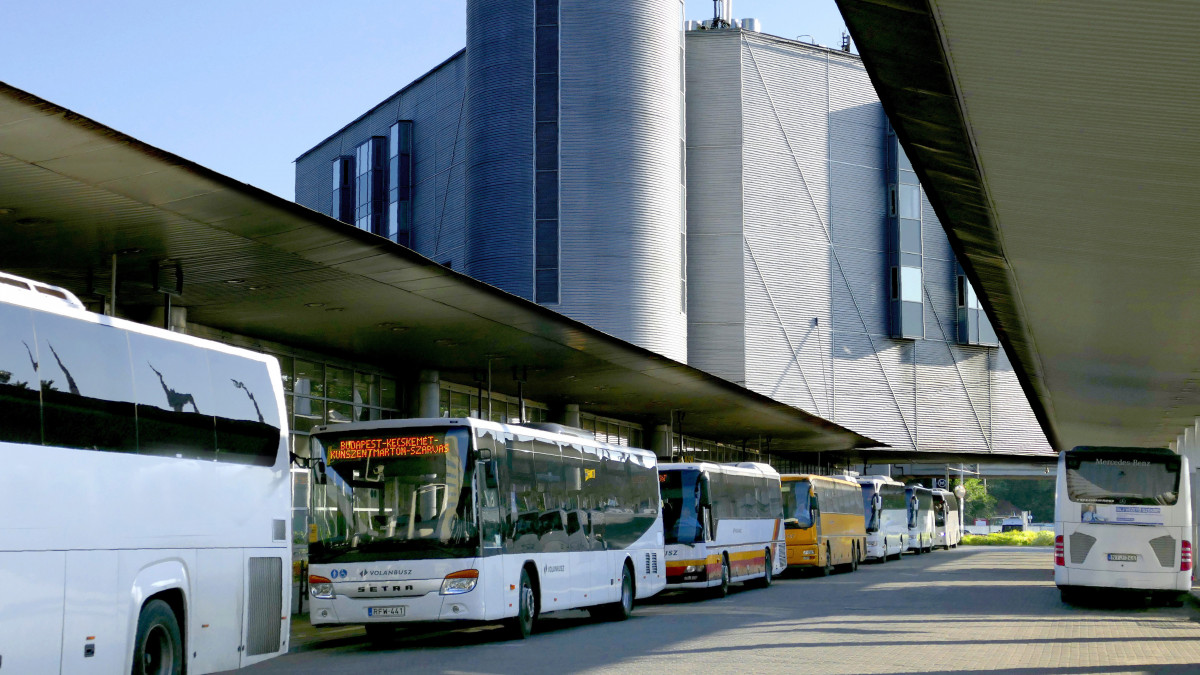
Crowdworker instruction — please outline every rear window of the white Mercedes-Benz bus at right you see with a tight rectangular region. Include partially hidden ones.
[1067,453,1180,506]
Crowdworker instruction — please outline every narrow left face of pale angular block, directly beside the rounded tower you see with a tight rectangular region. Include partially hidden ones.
[686,31,745,384]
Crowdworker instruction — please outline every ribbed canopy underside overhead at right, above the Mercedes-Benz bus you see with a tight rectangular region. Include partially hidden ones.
[839,0,1200,449]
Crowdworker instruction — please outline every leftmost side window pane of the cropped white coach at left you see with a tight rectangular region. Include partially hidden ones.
[0,305,42,444]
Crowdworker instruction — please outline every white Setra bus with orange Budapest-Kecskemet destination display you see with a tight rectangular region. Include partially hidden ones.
[308,418,666,641]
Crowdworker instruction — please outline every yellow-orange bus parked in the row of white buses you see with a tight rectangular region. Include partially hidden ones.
[780,474,866,577]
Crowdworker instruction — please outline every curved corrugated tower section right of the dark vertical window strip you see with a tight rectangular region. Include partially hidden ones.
[559,0,688,360]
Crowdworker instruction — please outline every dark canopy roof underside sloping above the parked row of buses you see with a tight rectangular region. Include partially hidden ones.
[0,83,880,453]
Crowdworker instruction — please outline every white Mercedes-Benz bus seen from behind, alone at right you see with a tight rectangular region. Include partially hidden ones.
[1054,447,1192,602]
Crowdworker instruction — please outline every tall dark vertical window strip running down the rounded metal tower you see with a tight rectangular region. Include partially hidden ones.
[534,0,559,304]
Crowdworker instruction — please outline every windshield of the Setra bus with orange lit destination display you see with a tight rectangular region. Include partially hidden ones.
[308,429,479,563]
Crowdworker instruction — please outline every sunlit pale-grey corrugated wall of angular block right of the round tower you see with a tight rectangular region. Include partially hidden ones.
[688,30,1049,452]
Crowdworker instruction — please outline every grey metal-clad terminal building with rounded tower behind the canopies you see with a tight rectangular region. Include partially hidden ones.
[295,0,1051,461]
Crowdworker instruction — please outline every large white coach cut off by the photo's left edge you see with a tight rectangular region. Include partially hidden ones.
[0,270,292,674]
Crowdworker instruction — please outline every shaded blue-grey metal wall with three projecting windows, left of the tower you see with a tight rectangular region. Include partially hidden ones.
[295,53,467,269]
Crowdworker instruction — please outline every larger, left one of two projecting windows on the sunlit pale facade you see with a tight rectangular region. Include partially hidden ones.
[887,125,925,339]
